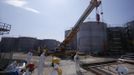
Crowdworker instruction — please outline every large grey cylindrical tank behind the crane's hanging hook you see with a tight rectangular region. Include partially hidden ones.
[77,22,107,54]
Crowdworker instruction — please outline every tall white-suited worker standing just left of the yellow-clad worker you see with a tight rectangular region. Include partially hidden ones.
[37,52,45,75]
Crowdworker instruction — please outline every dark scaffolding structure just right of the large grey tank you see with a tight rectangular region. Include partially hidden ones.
[107,27,125,55]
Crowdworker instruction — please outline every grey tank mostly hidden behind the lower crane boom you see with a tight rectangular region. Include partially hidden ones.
[65,30,77,50]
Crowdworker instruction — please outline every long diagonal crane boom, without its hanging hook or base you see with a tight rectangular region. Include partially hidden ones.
[58,0,101,49]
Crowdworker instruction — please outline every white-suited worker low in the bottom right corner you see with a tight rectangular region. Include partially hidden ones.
[116,61,128,75]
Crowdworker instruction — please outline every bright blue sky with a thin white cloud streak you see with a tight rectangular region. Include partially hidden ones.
[0,0,134,41]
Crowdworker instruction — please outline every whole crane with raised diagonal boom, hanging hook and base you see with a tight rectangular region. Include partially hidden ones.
[51,0,101,56]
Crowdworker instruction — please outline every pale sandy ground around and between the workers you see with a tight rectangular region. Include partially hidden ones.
[13,53,134,75]
